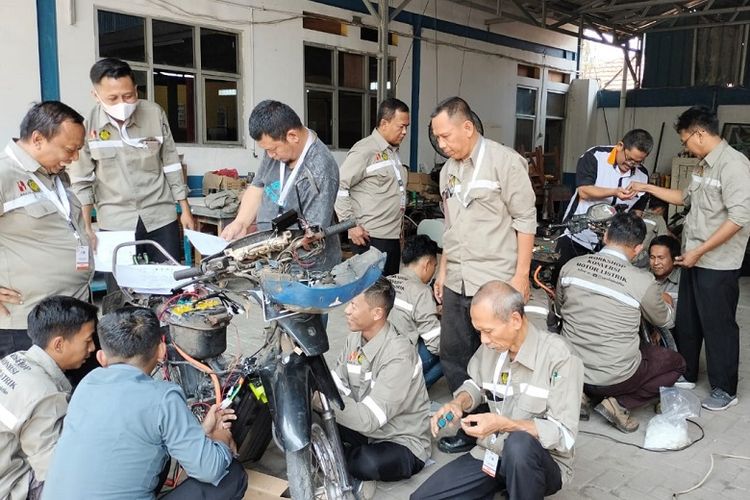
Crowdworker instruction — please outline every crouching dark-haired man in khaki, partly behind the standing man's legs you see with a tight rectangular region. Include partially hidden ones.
[388,234,443,389]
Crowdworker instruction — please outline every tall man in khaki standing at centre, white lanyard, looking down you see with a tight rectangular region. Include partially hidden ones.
[432,97,536,391]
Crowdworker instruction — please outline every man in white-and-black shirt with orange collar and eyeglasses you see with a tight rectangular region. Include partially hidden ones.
[555,129,654,278]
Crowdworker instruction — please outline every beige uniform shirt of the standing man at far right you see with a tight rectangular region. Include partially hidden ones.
[682,141,750,270]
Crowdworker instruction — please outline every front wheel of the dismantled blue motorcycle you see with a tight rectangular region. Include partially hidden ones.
[286,421,355,500]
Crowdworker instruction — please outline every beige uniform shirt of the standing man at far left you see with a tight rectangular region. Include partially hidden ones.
[0,141,94,330]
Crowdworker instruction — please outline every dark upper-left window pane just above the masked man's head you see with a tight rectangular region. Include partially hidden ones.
[97,10,146,62]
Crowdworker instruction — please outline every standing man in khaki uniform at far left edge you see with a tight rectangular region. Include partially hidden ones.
[0,101,94,357]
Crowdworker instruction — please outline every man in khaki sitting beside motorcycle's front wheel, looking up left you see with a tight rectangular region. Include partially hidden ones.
[331,277,430,481]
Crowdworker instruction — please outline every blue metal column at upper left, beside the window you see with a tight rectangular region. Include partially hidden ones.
[36,0,60,101]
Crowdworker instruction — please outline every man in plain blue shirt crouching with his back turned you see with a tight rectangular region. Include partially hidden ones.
[43,307,247,500]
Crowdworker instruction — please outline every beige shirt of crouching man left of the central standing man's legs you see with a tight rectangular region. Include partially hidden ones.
[388,267,440,356]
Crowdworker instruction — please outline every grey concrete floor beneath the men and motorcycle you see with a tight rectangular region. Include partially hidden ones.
[228,278,750,500]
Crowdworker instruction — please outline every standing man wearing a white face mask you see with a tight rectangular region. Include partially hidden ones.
[70,58,195,261]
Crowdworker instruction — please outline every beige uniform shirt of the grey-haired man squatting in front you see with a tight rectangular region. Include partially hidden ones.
[453,323,583,484]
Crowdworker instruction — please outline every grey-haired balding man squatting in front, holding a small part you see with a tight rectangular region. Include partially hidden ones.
[411,281,583,500]
